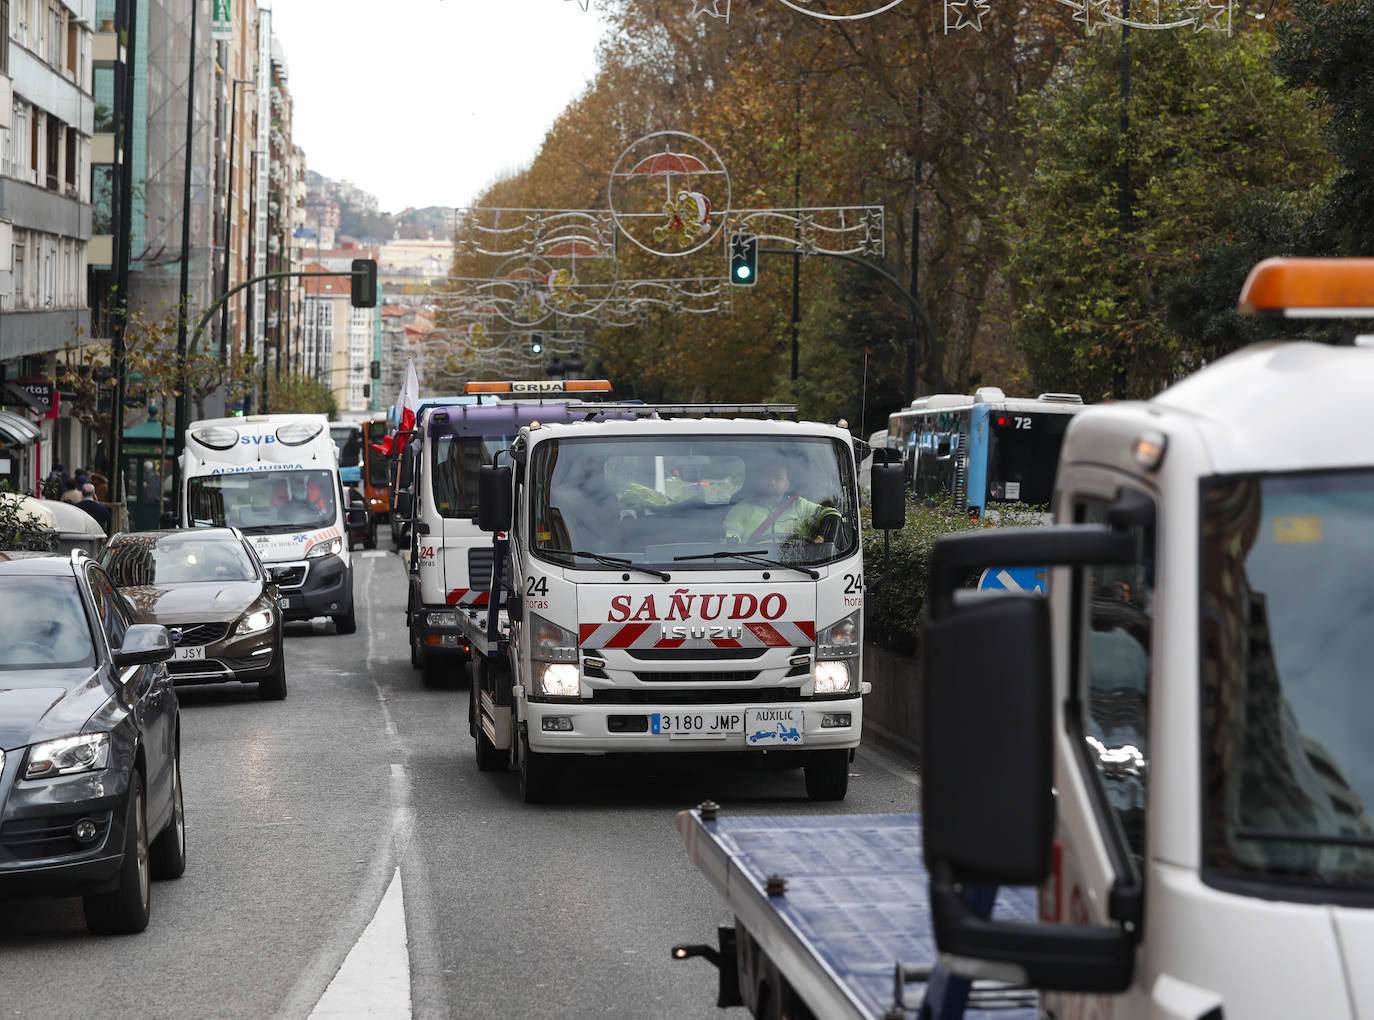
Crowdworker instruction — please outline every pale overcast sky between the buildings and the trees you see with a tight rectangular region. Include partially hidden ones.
[260,0,600,213]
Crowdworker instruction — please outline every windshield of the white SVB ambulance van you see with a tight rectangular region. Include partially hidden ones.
[187,470,338,532]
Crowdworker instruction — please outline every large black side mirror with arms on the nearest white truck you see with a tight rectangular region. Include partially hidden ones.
[921,525,1136,993]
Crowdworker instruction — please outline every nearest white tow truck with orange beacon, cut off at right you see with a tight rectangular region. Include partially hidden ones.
[677,258,1374,1020]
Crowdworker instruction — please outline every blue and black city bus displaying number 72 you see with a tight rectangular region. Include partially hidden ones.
[888,386,1084,517]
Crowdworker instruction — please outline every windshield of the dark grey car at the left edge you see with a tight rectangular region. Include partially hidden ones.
[0,576,95,670]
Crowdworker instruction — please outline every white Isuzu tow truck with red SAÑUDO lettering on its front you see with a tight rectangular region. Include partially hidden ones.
[459,404,867,801]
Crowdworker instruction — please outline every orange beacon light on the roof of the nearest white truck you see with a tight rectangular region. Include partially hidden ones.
[1238,258,1374,319]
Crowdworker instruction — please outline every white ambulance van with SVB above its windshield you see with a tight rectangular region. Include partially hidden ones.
[177,414,365,634]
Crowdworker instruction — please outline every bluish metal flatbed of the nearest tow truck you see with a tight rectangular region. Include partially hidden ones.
[677,806,1037,1020]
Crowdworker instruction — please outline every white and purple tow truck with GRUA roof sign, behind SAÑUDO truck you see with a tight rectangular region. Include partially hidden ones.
[397,379,610,687]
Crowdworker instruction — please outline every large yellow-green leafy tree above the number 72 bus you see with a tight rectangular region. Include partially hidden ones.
[1009,32,1331,400]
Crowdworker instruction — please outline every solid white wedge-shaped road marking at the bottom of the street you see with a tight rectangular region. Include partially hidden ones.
[311,868,411,1020]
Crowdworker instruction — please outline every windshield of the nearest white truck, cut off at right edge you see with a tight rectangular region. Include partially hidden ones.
[1200,470,1374,889]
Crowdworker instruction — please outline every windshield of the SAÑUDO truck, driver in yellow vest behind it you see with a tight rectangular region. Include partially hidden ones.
[530,436,859,570]
